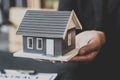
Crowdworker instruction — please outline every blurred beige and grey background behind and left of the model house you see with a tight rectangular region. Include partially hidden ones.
[0,0,59,53]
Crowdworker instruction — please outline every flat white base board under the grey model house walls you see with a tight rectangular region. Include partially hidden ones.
[14,49,79,61]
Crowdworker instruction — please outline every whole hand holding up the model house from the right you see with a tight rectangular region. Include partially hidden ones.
[70,30,106,62]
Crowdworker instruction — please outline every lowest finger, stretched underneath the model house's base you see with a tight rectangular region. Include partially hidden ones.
[70,51,98,62]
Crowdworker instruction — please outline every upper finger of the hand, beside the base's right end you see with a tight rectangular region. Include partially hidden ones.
[79,39,101,55]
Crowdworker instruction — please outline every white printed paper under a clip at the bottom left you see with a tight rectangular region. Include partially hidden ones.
[0,73,57,80]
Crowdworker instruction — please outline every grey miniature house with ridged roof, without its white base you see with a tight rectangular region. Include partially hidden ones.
[16,10,82,56]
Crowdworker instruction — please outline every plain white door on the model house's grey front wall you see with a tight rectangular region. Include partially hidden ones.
[46,39,54,56]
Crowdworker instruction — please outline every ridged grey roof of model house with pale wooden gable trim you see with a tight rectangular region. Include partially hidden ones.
[16,10,82,39]
